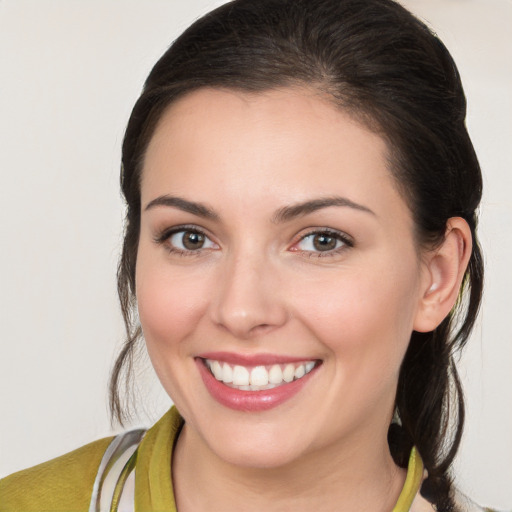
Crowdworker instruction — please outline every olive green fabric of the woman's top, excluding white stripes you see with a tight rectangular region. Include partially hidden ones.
[0,407,488,512]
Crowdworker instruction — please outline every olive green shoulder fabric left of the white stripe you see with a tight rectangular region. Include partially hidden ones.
[0,437,112,512]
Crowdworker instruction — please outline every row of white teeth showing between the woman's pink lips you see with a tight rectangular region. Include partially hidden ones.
[204,359,316,391]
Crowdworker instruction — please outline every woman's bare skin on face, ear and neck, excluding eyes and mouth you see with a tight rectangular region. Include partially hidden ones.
[136,88,471,512]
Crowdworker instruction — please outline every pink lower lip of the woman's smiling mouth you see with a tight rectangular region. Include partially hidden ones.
[196,359,318,412]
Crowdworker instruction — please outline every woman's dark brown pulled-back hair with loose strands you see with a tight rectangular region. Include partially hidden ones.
[110,0,483,511]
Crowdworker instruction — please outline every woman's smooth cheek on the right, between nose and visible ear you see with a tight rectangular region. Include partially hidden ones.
[293,267,416,369]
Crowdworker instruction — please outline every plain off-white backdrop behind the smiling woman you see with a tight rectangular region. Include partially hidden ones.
[0,0,512,508]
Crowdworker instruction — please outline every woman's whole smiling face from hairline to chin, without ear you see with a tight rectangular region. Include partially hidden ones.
[136,89,432,467]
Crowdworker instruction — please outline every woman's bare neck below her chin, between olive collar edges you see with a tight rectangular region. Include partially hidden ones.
[172,425,405,512]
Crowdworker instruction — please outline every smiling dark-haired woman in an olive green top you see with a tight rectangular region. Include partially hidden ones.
[0,0,504,512]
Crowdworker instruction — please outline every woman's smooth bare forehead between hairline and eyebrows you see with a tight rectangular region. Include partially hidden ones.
[142,88,412,226]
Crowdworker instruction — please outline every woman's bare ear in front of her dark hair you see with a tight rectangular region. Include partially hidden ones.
[413,217,473,332]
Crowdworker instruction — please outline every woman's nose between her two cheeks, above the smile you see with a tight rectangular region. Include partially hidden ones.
[208,255,288,339]
